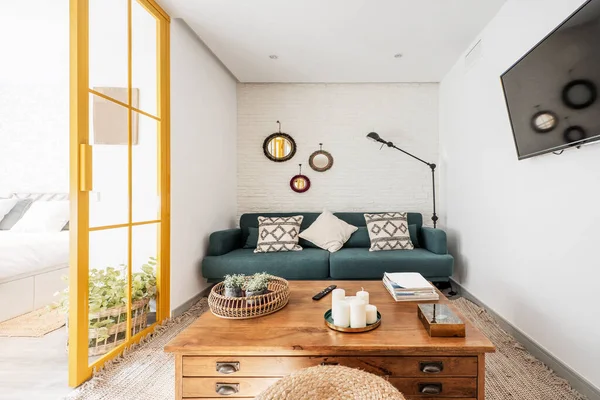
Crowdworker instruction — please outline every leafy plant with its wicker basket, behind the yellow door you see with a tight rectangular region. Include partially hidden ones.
[56,257,157,356]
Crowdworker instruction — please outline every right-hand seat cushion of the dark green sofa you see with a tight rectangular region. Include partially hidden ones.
[329,248,454,280]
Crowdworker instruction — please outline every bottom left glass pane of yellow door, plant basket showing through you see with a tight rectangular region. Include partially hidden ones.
[88,228,129,364]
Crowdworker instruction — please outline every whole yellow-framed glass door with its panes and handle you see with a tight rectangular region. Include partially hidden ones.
[68,0,170,386]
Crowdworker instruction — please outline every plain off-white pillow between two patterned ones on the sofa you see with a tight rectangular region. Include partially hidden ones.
[300,210,358,253]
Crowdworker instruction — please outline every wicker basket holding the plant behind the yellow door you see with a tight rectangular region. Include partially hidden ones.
[88,298,150,356]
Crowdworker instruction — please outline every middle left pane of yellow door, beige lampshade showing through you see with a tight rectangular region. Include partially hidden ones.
[89,94,129,228]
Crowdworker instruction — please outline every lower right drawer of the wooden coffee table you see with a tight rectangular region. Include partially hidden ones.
[389,377,477,399]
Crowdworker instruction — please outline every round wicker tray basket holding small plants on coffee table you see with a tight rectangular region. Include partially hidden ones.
[208,277,290,319]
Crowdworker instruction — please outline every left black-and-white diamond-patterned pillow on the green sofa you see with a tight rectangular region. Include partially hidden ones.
[254,215,304,253]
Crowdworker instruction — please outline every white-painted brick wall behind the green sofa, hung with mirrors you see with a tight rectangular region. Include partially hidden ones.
[237,84,439,222]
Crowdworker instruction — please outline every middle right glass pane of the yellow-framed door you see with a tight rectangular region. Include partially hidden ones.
[131,112,160,222]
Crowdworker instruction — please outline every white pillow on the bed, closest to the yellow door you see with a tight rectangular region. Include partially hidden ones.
[11,201,69,232]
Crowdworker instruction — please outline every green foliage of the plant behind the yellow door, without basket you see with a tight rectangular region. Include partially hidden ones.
[55,257,157,347]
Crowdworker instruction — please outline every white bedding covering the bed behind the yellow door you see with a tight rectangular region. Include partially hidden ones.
[0,231,69,283]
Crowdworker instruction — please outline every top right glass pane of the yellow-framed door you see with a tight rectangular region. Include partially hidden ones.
[131,0,158,116]
